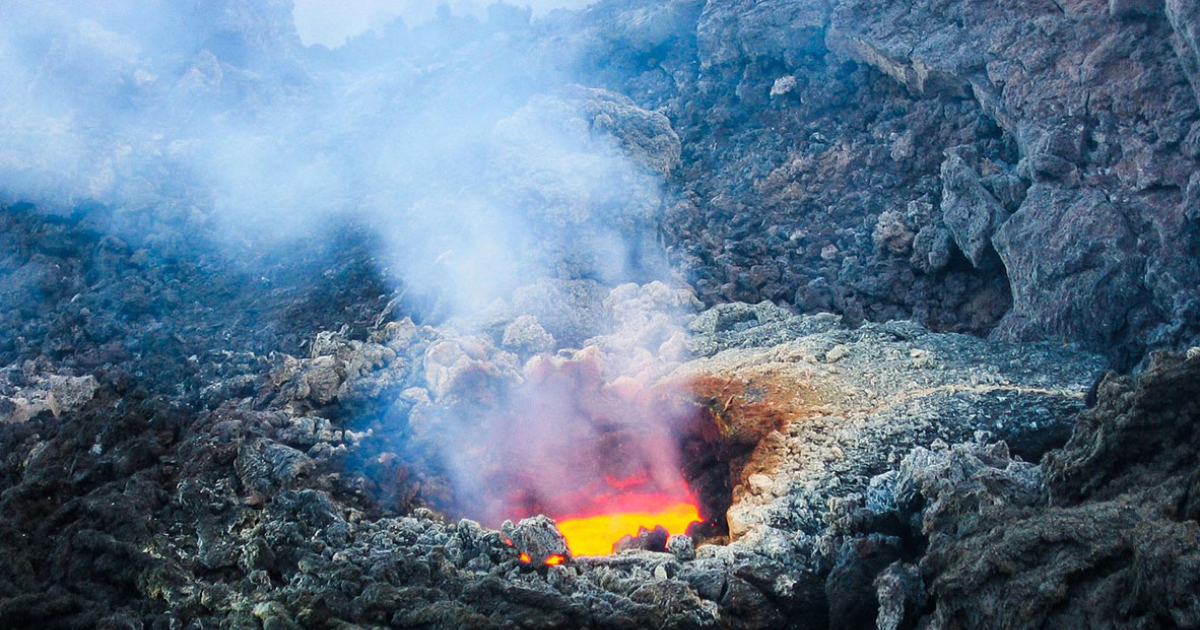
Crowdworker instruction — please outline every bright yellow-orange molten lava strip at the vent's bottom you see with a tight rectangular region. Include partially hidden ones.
[558,503,702,556]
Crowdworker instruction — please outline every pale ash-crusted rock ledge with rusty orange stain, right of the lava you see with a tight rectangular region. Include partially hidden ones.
[668,304,1103,538]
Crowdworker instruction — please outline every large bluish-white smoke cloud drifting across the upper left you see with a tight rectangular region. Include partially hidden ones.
[0,0,670,311]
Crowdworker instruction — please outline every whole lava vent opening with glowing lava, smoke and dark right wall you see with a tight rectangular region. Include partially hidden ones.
[408,348,792,554]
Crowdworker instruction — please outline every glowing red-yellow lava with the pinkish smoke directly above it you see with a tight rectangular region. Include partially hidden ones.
[455,347,703,554]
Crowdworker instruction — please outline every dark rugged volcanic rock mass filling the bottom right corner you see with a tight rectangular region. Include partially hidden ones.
[844,348,1200,629]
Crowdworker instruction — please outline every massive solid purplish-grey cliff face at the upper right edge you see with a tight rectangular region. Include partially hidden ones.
[833,2,1198,362]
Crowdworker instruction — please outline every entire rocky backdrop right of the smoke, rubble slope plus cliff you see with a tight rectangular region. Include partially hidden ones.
[556,0,1200,365]
